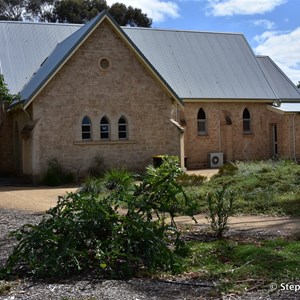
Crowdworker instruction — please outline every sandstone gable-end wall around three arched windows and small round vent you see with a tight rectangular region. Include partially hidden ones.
[31,21,180,176]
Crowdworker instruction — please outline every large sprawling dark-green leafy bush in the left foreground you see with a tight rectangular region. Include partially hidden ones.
[1,158,195,278]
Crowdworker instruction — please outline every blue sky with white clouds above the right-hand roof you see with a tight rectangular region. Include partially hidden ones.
[107,0,300,84]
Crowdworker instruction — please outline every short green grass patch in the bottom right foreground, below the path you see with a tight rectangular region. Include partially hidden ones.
[180,239,300,292]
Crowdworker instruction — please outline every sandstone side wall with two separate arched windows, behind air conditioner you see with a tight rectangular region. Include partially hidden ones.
[185,102,300,168]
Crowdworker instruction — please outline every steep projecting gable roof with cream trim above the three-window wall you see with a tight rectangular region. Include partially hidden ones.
[16,12,182,109]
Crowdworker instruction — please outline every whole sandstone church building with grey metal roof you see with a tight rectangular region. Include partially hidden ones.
[0,13,300,181]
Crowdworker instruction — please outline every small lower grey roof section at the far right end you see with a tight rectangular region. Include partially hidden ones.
[257,56,300,101]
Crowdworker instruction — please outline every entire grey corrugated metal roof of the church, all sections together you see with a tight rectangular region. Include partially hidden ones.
[0,13,299,105]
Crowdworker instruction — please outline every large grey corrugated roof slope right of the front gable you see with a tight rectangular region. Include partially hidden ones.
[123,27,276,99]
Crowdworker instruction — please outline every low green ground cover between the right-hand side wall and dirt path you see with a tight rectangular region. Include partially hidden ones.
[184,160,300,216]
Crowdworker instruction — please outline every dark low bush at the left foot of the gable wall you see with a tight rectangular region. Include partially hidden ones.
[43,159,75,186]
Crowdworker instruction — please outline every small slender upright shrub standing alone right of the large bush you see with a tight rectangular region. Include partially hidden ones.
[206,186,235,238]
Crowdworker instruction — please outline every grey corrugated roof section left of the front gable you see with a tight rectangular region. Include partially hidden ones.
[0,21,80,93]
